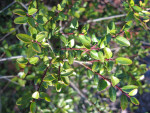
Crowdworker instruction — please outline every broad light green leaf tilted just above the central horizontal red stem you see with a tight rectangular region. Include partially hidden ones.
[79,35,91,49]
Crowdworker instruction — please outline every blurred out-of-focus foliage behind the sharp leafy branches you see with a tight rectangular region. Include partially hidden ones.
[0,0,150,113]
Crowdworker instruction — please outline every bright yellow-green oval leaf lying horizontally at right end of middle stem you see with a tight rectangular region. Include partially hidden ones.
[116,57,132,65]
